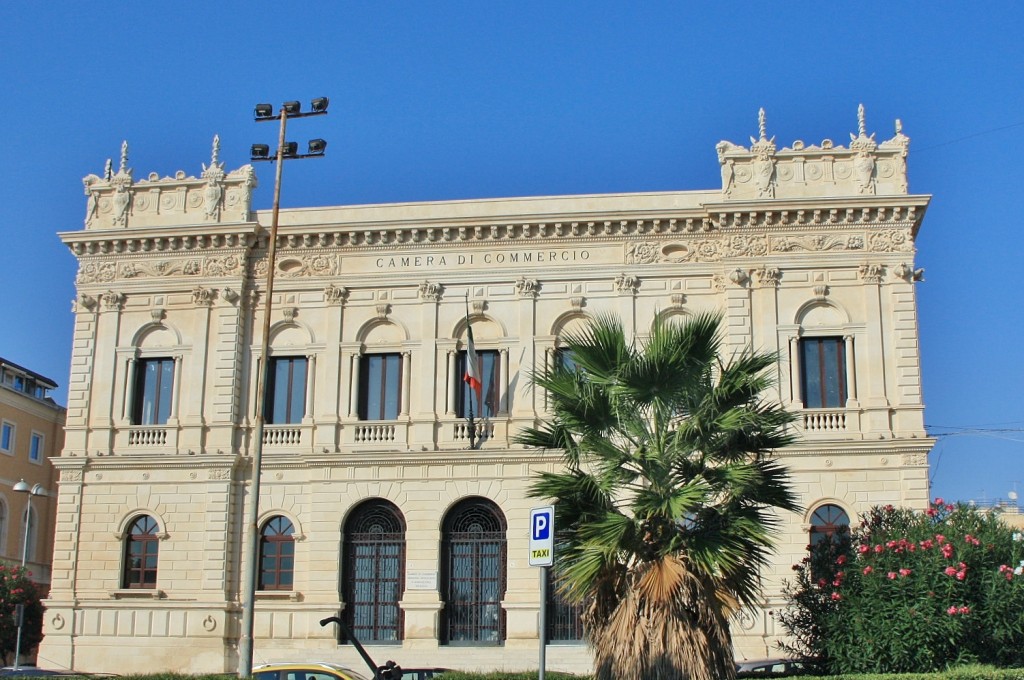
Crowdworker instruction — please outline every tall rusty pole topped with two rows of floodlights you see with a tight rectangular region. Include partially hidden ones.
[239,97,329,678]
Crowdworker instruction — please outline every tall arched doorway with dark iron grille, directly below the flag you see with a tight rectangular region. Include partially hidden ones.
[441,499,506,644]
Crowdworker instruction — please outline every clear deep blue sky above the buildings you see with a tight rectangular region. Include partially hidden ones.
[0,1,1024,501]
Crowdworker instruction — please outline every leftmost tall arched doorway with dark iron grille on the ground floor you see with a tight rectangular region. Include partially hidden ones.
[343,501,406,642]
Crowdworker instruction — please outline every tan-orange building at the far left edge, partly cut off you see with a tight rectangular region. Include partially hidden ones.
[0,357,65,593]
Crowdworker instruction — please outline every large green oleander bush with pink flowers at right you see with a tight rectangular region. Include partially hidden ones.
[777,499,1024,678]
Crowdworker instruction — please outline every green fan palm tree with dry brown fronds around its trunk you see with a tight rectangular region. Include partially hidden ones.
[516,313,799,680]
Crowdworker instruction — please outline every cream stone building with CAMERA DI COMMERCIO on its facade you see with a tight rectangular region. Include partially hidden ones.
[41,111,932,672]
